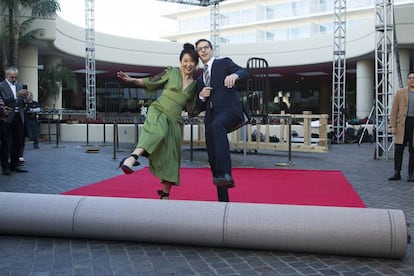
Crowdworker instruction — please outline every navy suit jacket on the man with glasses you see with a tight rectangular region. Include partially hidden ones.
[197,58,248,132]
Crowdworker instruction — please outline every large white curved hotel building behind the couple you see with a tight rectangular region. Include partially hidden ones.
[7,0,414,119]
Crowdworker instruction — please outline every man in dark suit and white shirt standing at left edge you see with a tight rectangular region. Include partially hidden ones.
[0,67,28,174]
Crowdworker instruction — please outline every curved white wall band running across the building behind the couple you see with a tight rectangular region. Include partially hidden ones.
[42,3,414,70]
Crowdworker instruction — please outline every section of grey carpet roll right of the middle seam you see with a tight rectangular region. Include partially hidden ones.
[225,204,408,258]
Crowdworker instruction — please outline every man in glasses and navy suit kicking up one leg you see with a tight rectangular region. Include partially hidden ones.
[195,39,248,202]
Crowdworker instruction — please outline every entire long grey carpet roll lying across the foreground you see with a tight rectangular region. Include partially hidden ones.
[0,193,408,258]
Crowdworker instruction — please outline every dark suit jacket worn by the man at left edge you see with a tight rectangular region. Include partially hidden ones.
[0,80,24,123]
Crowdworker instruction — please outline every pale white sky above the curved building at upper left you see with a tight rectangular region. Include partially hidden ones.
[58,0,179,40]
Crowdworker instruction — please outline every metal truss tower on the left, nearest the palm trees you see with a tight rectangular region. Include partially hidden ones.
[85,0,96,119]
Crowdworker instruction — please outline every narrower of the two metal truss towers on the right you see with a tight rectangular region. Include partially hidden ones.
[331,0,346,143]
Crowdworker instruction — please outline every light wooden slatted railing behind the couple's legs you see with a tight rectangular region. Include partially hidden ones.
[184,112,330,153]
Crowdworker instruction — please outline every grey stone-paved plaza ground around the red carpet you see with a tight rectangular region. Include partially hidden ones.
[0,142,414,276]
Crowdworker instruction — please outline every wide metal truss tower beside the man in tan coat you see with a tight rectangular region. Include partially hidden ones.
[375,0,395,160]
